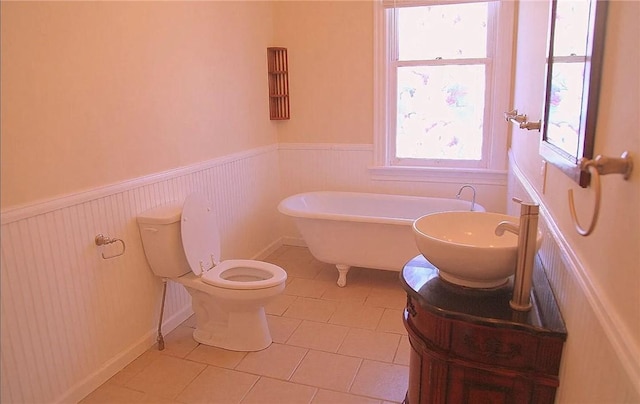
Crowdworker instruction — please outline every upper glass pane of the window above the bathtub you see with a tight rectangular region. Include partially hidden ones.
[398,3,488,60]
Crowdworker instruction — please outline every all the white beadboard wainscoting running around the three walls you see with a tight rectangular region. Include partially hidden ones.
[5,140,640,403]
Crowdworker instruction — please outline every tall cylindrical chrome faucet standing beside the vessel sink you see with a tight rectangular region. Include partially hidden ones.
[495,198,540,311]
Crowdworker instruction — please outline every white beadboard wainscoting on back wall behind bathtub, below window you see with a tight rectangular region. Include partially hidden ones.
[278,143,507,245]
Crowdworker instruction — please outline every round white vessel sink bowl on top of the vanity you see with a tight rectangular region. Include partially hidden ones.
[413,211,542,288]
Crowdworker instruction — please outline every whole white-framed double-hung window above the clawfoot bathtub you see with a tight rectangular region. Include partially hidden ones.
[374,0,514,178]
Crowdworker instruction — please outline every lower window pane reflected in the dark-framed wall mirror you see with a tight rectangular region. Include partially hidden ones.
[546,62,585,155]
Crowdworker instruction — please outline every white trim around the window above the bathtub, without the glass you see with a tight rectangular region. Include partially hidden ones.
[370,0,515,182]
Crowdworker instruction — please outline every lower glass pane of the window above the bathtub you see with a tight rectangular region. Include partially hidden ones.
[396,65,485,160]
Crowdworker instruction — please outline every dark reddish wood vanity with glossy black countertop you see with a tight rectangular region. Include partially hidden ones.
[400,255,567,404]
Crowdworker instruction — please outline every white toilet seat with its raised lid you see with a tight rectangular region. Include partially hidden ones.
[180,193,287,290]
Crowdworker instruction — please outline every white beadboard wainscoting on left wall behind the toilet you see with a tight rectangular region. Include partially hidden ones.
[0,145,280,403]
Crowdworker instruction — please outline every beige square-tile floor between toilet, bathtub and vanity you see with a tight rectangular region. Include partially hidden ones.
[82,246,409,404]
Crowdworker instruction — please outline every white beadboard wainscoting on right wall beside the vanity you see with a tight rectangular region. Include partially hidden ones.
[507,156,640,403]
